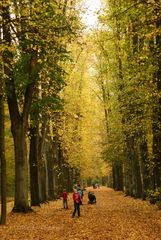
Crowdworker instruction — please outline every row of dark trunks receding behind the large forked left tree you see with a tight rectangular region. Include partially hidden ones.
[29,124,72,206]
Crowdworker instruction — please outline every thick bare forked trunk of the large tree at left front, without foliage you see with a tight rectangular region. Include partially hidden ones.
[3,6,32,212]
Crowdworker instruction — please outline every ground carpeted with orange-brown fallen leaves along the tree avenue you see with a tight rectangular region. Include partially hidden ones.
[0,187,161,240]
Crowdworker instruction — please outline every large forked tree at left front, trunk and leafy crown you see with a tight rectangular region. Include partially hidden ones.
[3,0,79,212]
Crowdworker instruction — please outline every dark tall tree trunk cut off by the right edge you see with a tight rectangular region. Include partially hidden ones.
[153,1,161,189]
